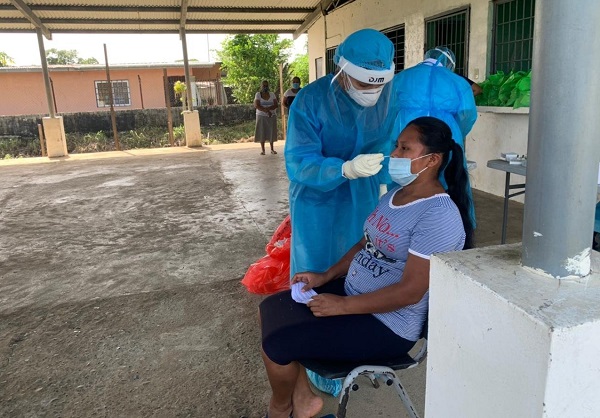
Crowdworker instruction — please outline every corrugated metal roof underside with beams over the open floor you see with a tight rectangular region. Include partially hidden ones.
[0,0,333,37]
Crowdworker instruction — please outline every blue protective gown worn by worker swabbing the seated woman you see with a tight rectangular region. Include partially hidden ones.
[285,74,393,277]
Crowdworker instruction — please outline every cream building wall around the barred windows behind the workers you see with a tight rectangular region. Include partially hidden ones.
[308,0,529,201]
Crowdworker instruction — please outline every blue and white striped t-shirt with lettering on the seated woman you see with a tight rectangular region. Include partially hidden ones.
[345,188,465,341]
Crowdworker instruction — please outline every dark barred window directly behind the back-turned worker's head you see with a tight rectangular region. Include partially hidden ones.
[425,8,470,76]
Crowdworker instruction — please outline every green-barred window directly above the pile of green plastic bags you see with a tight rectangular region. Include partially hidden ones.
[491,0,535,73]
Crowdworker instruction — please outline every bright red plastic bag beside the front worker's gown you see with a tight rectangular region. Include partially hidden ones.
[242,215,292,295]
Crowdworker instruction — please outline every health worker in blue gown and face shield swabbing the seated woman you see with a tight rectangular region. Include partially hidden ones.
[285,29,394,277]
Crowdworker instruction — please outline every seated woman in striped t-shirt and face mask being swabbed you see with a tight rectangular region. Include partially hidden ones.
[260,117,473,418]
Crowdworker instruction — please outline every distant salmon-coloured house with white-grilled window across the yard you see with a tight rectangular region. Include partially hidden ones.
[0,63,226,116]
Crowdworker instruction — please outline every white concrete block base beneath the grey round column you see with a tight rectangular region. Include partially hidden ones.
[425,244,600,418]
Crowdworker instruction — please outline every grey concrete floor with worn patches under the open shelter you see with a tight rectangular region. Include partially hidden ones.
[0,142,523,418]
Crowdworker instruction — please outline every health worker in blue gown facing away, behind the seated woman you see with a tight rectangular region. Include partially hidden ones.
[390,46,477,225]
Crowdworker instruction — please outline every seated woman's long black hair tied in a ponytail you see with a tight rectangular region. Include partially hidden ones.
[408,116,474,250]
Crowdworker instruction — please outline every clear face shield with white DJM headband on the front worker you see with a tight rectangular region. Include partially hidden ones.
[327,57,394,132]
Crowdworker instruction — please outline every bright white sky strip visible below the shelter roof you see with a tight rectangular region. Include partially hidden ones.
[0,33,306,66]
